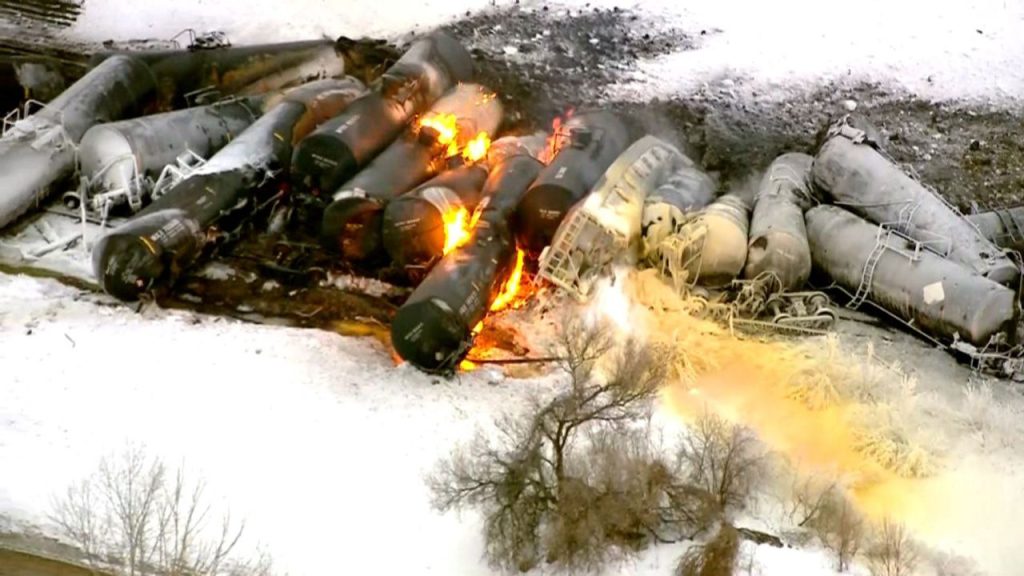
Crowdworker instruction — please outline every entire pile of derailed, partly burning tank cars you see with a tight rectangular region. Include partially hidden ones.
[0,32,1024,372]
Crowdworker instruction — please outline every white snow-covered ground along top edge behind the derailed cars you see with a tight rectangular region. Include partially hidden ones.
[71,0,1024,107]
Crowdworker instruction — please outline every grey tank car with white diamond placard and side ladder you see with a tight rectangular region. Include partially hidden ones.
[806,205,1015,345]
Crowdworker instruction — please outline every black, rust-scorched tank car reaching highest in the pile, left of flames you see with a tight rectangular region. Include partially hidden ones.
[292,32,473,194]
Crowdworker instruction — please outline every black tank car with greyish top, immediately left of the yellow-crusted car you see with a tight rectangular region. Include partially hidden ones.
[516,111,632,256]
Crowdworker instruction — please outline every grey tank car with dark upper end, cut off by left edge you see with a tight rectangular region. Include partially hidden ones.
[0,56,156,229]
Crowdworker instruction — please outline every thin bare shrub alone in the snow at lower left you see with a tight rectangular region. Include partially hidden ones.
[50,446,270,576]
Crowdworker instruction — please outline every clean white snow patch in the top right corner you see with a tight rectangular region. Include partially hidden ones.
[597,0,1024,107]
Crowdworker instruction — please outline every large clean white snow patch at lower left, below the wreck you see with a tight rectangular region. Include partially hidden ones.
[0,276,550,574]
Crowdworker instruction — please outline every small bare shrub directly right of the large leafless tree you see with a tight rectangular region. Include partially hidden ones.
[679,411,764,512]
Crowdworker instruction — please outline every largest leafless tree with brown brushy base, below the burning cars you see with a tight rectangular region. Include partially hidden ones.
[427,319,713,572]
